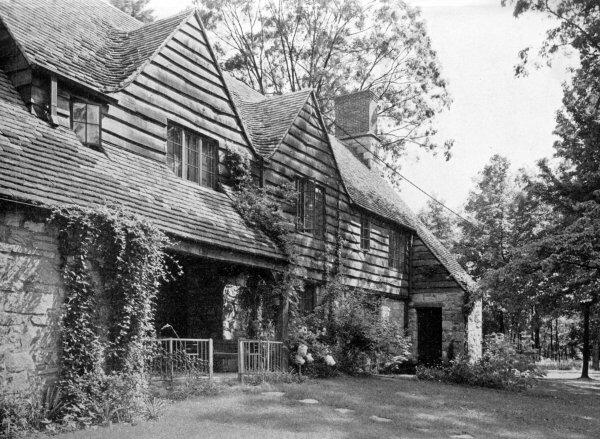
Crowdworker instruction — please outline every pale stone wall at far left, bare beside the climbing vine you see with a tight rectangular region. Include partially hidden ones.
[0,203,63,391]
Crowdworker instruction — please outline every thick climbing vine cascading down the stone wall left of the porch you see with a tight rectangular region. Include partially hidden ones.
[51,207,169,430]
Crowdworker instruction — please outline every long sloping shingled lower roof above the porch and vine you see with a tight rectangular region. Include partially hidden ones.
[0,70,284,260]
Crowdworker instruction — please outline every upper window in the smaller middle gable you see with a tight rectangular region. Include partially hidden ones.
[296,179,326,238]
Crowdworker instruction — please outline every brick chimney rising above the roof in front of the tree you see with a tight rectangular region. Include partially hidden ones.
[334,90,381,168]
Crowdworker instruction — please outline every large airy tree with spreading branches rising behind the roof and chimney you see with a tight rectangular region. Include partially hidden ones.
[197,0,452,172]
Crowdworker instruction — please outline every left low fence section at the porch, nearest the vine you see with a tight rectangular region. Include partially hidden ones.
[148,338,213,381]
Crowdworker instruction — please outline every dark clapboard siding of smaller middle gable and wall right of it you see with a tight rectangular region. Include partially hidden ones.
[265,99,408,298]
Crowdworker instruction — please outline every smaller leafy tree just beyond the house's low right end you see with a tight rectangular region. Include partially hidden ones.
[454,155,548,338]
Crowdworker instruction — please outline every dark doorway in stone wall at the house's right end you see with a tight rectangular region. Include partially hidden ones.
[417,308,442,364]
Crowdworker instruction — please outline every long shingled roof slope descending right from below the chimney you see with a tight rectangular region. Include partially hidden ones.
[329,135,475,291]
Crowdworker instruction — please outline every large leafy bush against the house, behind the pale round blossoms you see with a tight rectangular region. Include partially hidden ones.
[290,281,410,376]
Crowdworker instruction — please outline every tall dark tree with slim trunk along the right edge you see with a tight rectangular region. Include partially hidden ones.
[502,0,600,378]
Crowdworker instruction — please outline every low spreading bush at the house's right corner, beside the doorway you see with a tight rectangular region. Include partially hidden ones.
[416,334,544,390]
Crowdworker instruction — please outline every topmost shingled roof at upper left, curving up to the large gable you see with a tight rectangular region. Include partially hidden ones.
[0,0,193,92]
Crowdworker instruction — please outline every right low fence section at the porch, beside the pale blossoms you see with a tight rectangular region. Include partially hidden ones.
[238,340,287,380]
